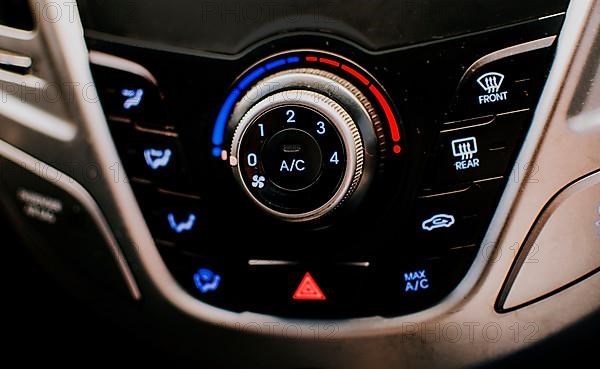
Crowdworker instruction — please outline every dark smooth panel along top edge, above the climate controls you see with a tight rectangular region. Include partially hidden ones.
[78,0,568,54]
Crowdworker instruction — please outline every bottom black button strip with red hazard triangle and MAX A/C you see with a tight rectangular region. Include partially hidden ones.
[159,247,476,318]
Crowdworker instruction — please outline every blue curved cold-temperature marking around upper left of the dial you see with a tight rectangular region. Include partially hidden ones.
[212,56,300,158]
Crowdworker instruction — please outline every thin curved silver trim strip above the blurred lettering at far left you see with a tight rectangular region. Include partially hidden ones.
[0,140,142,300]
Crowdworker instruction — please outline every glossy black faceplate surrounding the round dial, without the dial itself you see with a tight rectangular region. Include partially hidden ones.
[88,17,562,318]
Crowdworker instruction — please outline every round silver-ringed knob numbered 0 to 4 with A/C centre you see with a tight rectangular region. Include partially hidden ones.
[230,69,377,222]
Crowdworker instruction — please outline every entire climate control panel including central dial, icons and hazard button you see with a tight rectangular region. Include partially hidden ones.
[88,12,562,318]
